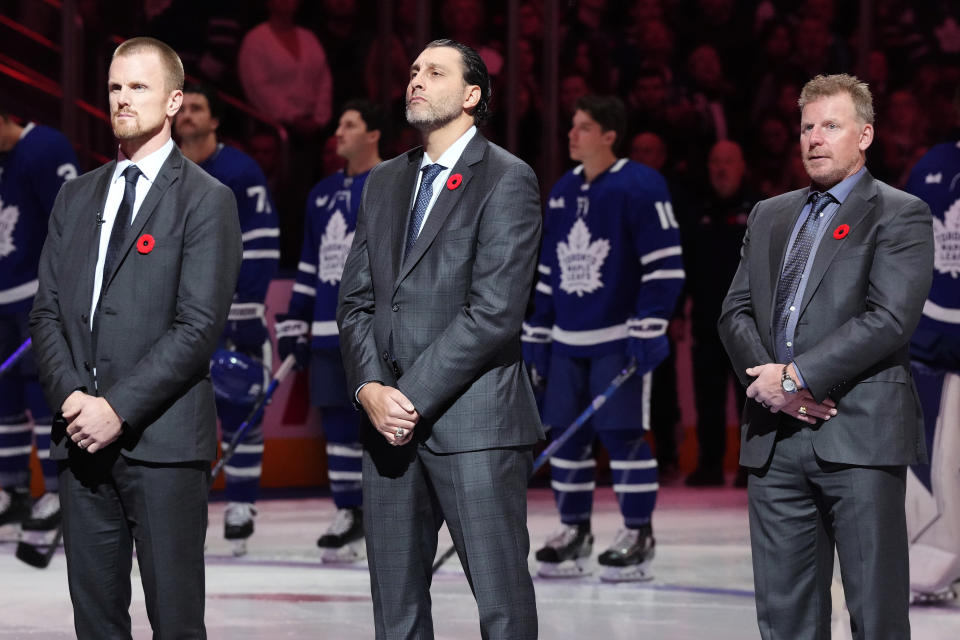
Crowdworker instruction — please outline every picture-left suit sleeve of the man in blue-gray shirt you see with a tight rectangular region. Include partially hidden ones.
[717,203,780,387]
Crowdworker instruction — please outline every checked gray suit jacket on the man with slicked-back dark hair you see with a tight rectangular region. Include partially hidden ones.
[337,133,543,453]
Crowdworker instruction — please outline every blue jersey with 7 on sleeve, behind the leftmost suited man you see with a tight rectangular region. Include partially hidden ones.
[200,143,280,320]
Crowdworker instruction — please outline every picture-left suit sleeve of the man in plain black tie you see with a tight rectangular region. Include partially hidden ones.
[30,182,85,414]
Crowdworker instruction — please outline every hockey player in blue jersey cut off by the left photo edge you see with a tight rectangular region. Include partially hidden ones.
[0,109,77,539]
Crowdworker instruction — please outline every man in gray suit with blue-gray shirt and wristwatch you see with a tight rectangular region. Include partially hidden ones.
[719,75,933,640]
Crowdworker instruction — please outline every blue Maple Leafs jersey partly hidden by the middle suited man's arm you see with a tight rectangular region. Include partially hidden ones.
[288,170,370,349]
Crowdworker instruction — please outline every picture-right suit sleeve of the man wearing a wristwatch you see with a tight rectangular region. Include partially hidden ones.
[795,198,933,400]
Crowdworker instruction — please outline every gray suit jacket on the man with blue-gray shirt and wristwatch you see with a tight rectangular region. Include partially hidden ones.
[719,172,933,468]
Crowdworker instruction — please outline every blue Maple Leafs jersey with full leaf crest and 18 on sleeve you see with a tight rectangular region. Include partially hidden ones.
[522,158,684,357]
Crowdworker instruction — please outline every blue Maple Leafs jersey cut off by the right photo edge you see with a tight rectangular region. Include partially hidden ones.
[906,142,960,368]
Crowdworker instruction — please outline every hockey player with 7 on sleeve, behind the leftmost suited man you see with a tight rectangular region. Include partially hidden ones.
[174,85,280,555]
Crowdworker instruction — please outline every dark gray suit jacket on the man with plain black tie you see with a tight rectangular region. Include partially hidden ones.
[30,147,242,463]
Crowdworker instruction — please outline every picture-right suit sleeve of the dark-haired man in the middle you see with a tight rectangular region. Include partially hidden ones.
[397,163,541,417]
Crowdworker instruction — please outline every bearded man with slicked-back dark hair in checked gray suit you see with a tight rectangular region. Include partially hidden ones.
[337,40,543,639]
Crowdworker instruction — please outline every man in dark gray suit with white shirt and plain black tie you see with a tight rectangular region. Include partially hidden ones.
[30,38,241,639]
